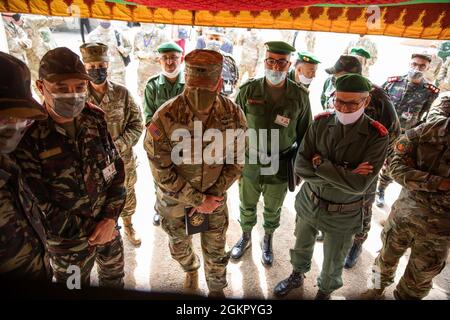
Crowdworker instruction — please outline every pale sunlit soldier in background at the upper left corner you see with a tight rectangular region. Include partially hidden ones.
[2,13,31,64]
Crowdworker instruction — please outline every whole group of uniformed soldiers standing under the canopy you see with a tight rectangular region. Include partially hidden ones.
[0,17,450,299]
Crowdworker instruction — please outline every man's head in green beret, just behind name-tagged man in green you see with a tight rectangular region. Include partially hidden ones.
[288,51,320,88]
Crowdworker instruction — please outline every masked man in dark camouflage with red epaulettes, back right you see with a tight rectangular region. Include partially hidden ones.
[376,53,439,207]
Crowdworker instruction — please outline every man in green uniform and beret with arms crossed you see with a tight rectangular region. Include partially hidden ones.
[274,74,389,299]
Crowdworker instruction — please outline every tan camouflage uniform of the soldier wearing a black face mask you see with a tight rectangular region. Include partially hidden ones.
[88,81,143,218]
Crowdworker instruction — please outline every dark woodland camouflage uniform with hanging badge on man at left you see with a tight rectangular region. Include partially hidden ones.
[15,104,126,287]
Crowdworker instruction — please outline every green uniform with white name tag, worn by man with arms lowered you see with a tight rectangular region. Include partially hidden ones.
[236,78,312,234]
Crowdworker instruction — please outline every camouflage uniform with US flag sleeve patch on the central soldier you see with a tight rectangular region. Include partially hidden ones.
[144,94,246,291]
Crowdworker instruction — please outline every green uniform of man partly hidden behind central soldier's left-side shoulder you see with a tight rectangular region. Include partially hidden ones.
[144,72,184,125]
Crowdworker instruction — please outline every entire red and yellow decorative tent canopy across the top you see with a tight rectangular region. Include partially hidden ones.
[0,0,450,39]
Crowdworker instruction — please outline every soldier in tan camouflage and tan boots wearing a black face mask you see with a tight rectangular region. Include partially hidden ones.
[80,43,143,246]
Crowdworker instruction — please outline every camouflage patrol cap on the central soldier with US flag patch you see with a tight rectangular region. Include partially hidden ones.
[184,49,223,89]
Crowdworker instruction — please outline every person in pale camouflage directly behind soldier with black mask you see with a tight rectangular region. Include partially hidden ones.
[86,20,132,86]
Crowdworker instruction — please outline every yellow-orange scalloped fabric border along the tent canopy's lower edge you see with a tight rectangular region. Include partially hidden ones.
[0,0,450,39]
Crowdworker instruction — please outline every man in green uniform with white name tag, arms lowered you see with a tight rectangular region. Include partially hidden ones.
[231,41,312,266]
